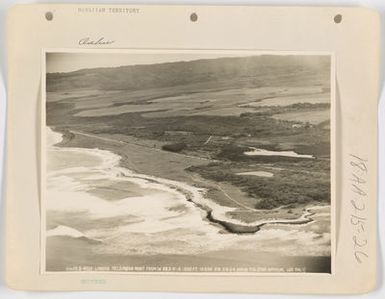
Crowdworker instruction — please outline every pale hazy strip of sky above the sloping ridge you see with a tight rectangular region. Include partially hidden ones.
[46,51,255,73]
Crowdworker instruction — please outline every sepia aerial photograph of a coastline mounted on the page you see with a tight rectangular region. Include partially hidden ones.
[42,50,334,275]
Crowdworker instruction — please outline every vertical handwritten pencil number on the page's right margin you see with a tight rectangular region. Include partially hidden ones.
[349,154,369,264]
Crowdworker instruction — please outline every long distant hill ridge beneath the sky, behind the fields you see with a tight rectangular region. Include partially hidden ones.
[46,54,330,91]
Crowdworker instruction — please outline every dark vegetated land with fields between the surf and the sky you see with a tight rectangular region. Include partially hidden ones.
[46,56,331,223]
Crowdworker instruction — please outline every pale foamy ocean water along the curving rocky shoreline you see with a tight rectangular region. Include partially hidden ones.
[45,128,331,274]
